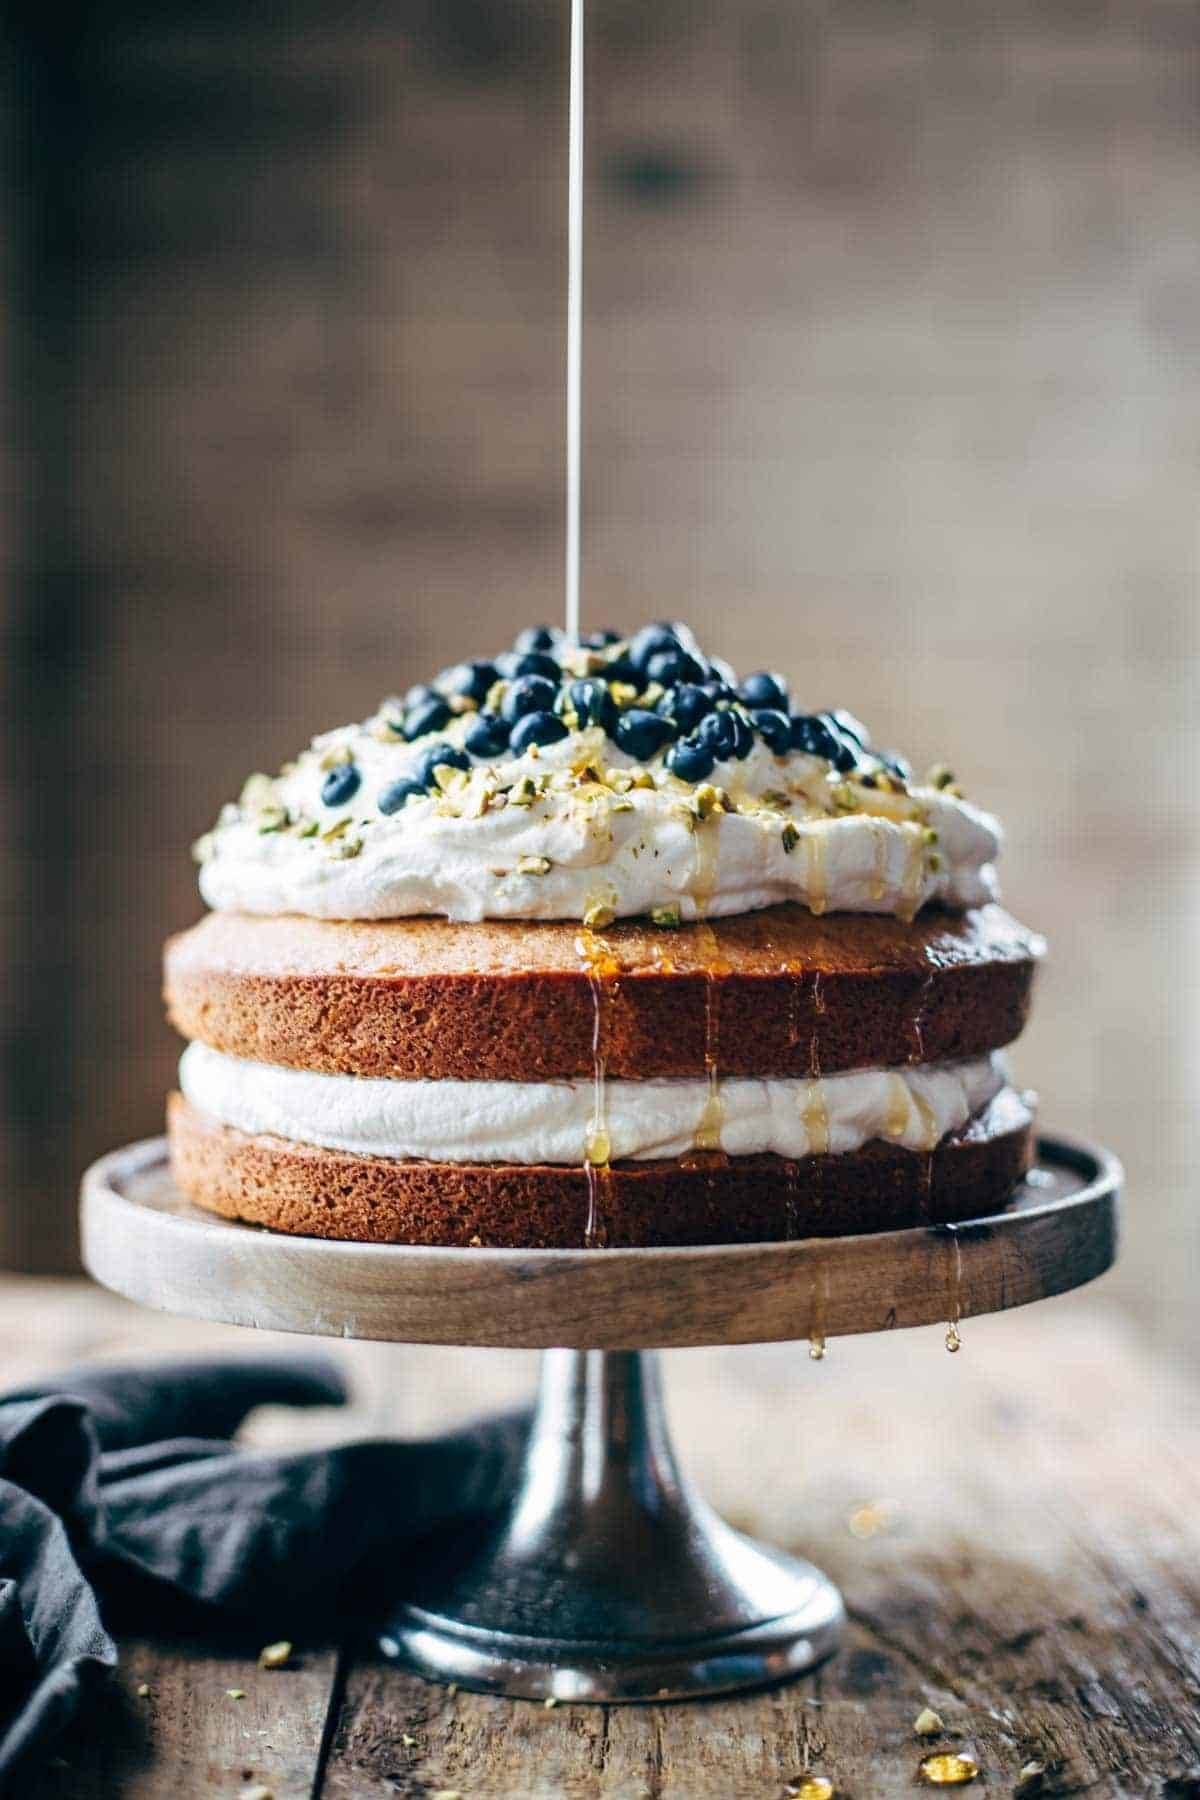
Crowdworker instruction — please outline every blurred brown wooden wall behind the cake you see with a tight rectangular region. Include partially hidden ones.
[0,0,1200,1345]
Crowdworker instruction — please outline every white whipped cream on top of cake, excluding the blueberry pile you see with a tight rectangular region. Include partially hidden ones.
[200,713,1000,923]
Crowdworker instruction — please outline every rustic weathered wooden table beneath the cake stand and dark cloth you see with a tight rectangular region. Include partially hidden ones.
[9,1280,1200,1800]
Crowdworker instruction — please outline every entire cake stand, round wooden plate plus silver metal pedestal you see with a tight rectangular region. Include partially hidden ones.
[83,1138,1121,1701]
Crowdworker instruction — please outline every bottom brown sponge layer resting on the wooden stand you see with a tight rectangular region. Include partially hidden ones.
[167,1087,1033,1249]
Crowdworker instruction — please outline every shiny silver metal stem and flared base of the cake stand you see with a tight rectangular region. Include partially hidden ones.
[380,1350,842,1701]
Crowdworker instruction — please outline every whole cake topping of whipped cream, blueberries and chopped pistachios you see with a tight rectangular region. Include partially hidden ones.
[196,625,1000,929]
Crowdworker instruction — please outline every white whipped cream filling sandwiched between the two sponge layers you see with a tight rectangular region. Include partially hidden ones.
[180,1042,1007,1165]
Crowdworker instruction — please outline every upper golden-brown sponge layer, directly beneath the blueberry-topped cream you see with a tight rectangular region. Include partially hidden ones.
[166,905,1042,1082]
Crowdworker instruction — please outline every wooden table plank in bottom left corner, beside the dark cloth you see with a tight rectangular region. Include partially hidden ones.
[31,1638,338,1800]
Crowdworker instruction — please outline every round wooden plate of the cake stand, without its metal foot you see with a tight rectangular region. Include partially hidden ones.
[83,1138,1121,1350]
